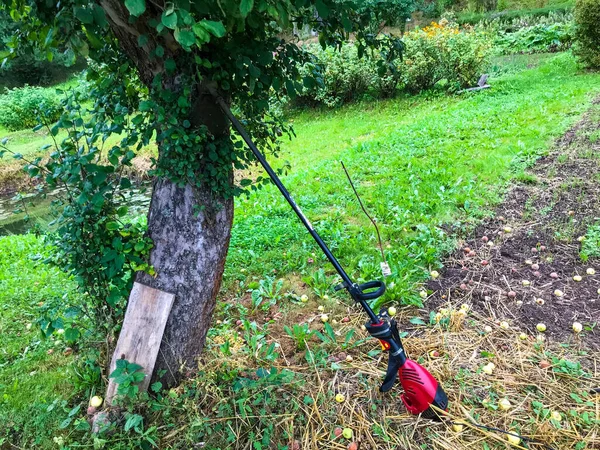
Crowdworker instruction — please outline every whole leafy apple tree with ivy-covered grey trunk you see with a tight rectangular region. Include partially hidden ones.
[0,0,411,384]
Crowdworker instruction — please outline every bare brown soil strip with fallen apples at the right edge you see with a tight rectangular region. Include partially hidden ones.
[428,98,600,348]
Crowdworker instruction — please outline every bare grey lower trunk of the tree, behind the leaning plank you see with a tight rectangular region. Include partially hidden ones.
[138,179,233,385]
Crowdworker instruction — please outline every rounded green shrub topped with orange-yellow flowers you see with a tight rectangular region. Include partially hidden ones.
[398,19,491,92]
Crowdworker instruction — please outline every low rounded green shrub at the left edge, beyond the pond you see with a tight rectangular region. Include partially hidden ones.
[0,86,62,131]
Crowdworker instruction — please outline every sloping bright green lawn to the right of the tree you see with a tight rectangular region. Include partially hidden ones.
[226,54,600,303]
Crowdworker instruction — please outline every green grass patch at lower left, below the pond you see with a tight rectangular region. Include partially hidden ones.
[0,235,76,448]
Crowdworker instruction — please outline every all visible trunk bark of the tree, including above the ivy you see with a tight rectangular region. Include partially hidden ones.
[100,0,233,385]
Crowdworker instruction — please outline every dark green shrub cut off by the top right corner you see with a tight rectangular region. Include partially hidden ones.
[575,0,600,68]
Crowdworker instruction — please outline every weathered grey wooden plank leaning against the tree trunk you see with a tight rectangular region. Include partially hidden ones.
[106,283,175,405]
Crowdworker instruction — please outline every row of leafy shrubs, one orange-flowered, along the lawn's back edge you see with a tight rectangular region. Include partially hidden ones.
[296,19,491,107]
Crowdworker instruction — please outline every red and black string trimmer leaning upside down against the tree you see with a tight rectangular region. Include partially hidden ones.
[213,92,448,419]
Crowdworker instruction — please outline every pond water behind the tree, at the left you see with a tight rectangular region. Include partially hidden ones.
[0,186,151,236]
